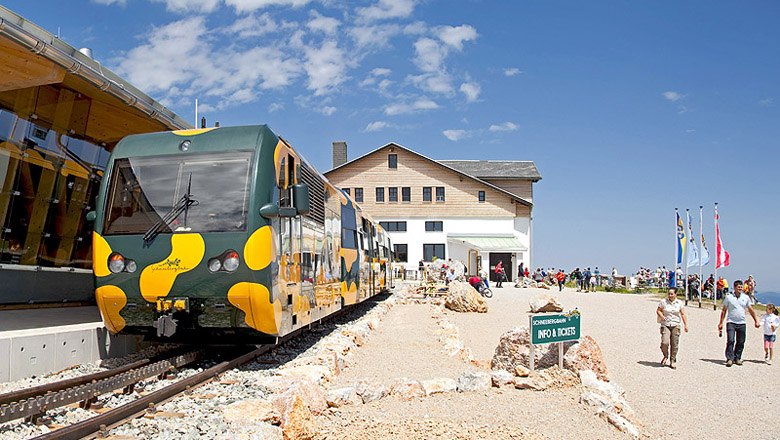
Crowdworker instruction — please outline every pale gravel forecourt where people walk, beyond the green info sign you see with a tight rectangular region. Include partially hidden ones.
[447,287,780,440]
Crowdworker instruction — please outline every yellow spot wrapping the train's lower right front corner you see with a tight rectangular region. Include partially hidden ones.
[228,282,282,335]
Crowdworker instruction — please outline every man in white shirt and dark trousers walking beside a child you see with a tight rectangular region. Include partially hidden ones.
[718,280,760,367]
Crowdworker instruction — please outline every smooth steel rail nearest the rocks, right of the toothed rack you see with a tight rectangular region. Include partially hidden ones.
[35,344,276,440]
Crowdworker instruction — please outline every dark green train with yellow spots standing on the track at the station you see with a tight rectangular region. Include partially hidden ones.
[88,125,392,343]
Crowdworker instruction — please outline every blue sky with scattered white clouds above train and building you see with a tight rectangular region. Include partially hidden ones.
[6,0,780,291]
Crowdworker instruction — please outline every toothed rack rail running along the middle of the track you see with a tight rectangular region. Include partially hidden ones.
[0,351,203,423]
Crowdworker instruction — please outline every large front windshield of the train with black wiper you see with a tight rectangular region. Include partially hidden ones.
[103,151,252,235]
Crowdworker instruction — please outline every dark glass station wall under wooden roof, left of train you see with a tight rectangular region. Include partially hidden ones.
[0,85,114,269]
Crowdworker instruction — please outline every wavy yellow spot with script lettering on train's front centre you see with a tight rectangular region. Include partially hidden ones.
[139,234,206,303]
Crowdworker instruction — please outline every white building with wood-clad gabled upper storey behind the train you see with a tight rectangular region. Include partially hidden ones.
[325,142,541,280]
